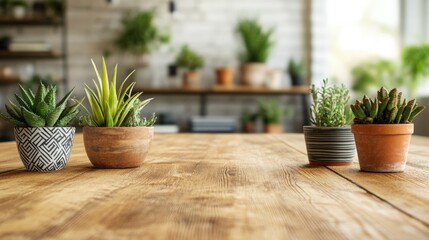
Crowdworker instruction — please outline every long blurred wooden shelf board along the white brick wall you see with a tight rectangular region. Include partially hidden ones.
[134,86,310,95]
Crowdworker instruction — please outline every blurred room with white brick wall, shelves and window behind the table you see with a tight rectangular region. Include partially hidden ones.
[0,0,429,140]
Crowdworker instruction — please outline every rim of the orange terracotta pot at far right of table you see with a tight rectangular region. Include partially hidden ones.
[351,123,414,135]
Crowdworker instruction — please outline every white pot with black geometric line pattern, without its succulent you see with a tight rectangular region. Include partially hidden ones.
[15,127,75,172]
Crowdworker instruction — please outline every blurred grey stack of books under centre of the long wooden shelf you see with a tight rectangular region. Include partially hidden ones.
[190,116,237,132]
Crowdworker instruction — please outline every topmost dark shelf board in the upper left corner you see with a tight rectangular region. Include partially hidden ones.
[0,17,63,26]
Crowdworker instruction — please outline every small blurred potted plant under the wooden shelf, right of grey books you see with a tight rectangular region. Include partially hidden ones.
[258,100,284,133]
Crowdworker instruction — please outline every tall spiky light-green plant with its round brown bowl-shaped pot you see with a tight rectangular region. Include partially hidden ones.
[81,58,156,168]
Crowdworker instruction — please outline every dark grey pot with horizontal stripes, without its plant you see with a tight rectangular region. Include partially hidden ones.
[304,126,356,166]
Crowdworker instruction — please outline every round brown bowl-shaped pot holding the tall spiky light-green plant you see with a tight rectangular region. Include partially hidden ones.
[83,127,153,168]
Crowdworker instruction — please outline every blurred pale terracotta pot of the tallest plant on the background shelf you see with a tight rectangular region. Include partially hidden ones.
[241,63,268,86]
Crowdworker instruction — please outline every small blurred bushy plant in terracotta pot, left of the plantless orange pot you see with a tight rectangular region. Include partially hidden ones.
[176,45,204,87]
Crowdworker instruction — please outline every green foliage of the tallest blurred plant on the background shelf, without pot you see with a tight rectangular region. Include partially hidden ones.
[237,18,274,63]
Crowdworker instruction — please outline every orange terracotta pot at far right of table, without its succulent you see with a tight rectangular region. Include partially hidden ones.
[352,123,414,172]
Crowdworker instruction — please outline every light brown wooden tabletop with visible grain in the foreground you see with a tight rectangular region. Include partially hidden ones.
[0,134,429,239]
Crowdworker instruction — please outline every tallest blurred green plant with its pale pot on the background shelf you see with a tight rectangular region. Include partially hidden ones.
[237,19,274,86]
